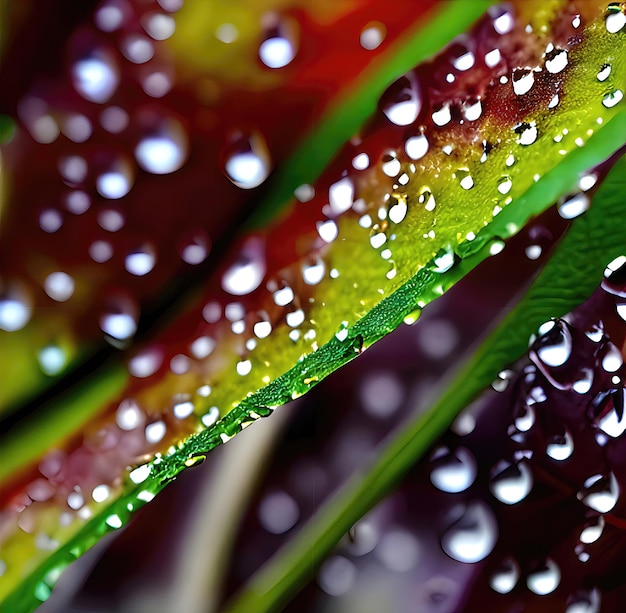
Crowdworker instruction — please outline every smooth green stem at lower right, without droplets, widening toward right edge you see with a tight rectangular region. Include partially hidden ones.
[225,157,626,613]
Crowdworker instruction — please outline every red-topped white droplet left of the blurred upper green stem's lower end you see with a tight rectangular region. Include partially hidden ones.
[224,132,272,189]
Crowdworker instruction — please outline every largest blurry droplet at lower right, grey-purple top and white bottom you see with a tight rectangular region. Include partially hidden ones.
[441,501,498,563]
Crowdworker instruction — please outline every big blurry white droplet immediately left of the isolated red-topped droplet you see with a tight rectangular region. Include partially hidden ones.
[135,118,188,175]
